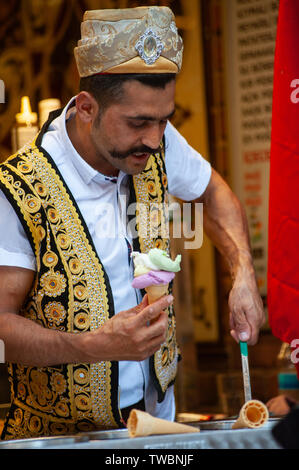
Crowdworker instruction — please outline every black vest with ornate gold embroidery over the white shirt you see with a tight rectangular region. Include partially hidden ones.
[0,118,179,440]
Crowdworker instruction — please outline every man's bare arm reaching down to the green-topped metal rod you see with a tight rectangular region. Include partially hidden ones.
[201,171,265,344]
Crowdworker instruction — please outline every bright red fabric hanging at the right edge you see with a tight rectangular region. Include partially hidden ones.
[268,0,299,343]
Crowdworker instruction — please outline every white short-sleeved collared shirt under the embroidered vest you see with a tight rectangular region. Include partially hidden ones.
[0,98,211,419]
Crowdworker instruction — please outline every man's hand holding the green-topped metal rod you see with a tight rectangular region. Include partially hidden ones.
[228,264,265,345]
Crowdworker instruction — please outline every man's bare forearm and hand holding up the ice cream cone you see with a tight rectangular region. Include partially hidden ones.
[0,296,173,367]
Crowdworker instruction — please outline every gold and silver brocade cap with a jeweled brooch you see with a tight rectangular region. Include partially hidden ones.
[74,7,183,77]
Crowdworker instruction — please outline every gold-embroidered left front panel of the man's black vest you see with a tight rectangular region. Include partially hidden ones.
[0,146,117,438]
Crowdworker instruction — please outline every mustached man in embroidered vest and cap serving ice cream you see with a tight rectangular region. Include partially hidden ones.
[0,7,263,439]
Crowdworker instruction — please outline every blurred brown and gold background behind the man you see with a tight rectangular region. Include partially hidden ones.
[0,0,288,415]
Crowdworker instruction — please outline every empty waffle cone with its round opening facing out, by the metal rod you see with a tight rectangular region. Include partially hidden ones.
[232,400,269,429]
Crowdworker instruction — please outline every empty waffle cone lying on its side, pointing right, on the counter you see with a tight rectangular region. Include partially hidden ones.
[127,409,199,437]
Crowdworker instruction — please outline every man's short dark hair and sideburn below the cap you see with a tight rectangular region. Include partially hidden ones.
[79,73,176,112]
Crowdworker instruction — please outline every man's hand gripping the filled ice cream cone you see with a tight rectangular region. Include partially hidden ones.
[87,295,173,362]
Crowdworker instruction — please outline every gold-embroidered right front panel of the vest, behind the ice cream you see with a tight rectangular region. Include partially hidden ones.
[133,149,179,395]
